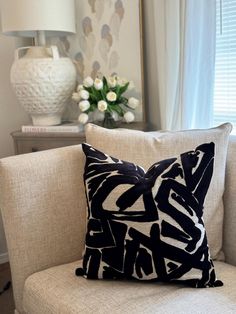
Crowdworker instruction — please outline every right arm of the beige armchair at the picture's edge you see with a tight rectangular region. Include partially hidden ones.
[223,136,236,266]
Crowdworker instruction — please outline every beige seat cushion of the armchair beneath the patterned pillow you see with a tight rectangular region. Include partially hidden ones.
[23,261,236,314]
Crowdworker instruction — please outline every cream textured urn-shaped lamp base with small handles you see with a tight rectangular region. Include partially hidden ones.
[11,46,76,125]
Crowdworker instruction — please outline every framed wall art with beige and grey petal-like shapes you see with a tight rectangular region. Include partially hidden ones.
[58,0,144,121]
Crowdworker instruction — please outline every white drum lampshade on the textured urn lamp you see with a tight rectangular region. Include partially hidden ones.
[1,0,75,37]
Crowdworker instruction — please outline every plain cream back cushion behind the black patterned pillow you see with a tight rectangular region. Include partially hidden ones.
[85,123,232,259]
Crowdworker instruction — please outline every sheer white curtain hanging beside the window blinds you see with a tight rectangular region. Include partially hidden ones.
[152,0,216,130]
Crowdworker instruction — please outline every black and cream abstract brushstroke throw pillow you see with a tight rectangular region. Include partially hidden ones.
[76,143,222,287]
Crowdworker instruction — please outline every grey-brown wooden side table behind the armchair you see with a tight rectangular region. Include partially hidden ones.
[11,122,147,155]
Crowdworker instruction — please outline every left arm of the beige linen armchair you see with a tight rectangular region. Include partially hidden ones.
[0,146,86,312]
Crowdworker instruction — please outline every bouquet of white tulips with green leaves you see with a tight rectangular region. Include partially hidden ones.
[72,76,139,128]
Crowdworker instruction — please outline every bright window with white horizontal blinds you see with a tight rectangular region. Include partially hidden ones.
[214,0,236,134]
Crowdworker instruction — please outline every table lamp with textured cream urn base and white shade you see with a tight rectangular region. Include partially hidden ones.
[1,0,76,125]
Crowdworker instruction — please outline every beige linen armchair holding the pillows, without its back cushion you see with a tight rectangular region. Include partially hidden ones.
[0,139,236,314]
